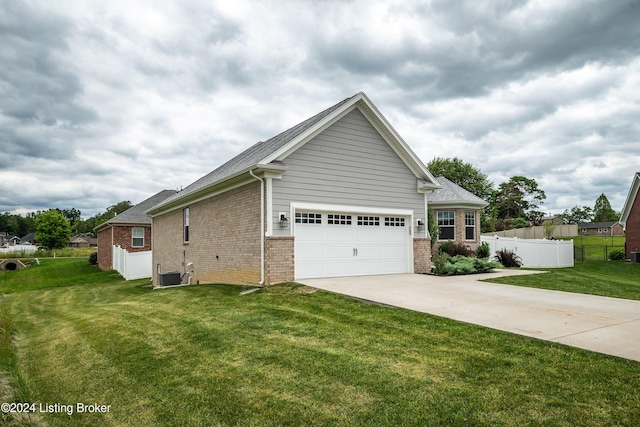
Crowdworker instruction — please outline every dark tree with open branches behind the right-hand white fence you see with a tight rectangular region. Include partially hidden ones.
[491,175,547,219]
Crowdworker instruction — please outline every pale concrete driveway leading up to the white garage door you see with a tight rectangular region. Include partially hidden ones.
[299,270,640,361]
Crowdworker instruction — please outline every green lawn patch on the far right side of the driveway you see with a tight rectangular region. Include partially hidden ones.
[487,261,640,300]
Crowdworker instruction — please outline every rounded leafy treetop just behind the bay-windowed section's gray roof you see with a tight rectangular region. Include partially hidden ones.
[427,157,493,201]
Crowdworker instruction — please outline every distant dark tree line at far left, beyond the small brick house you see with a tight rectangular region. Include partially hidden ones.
[0,201,133,237]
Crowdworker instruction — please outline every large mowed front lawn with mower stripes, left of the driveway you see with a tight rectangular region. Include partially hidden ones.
[0,259,640,426]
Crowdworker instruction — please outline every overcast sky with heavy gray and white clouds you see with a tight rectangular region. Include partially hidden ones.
[0,0,640,217]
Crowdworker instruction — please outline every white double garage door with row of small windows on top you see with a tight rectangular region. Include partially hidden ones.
[294,212,411,279]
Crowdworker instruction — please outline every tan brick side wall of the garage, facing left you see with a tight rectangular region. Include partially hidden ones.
[153,181,261,285]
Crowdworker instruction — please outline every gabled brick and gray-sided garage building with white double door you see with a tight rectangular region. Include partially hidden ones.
[147,93,440,285]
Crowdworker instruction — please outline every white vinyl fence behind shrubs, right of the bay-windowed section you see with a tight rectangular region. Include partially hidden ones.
[480,236,573,268]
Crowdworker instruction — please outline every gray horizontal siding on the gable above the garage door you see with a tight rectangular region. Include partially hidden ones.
[271,109,424,234]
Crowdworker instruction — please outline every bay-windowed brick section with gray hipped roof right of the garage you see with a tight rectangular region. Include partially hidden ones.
[427,176,488,254]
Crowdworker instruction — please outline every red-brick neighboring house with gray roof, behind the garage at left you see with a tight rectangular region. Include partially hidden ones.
[95,190,176,270]
